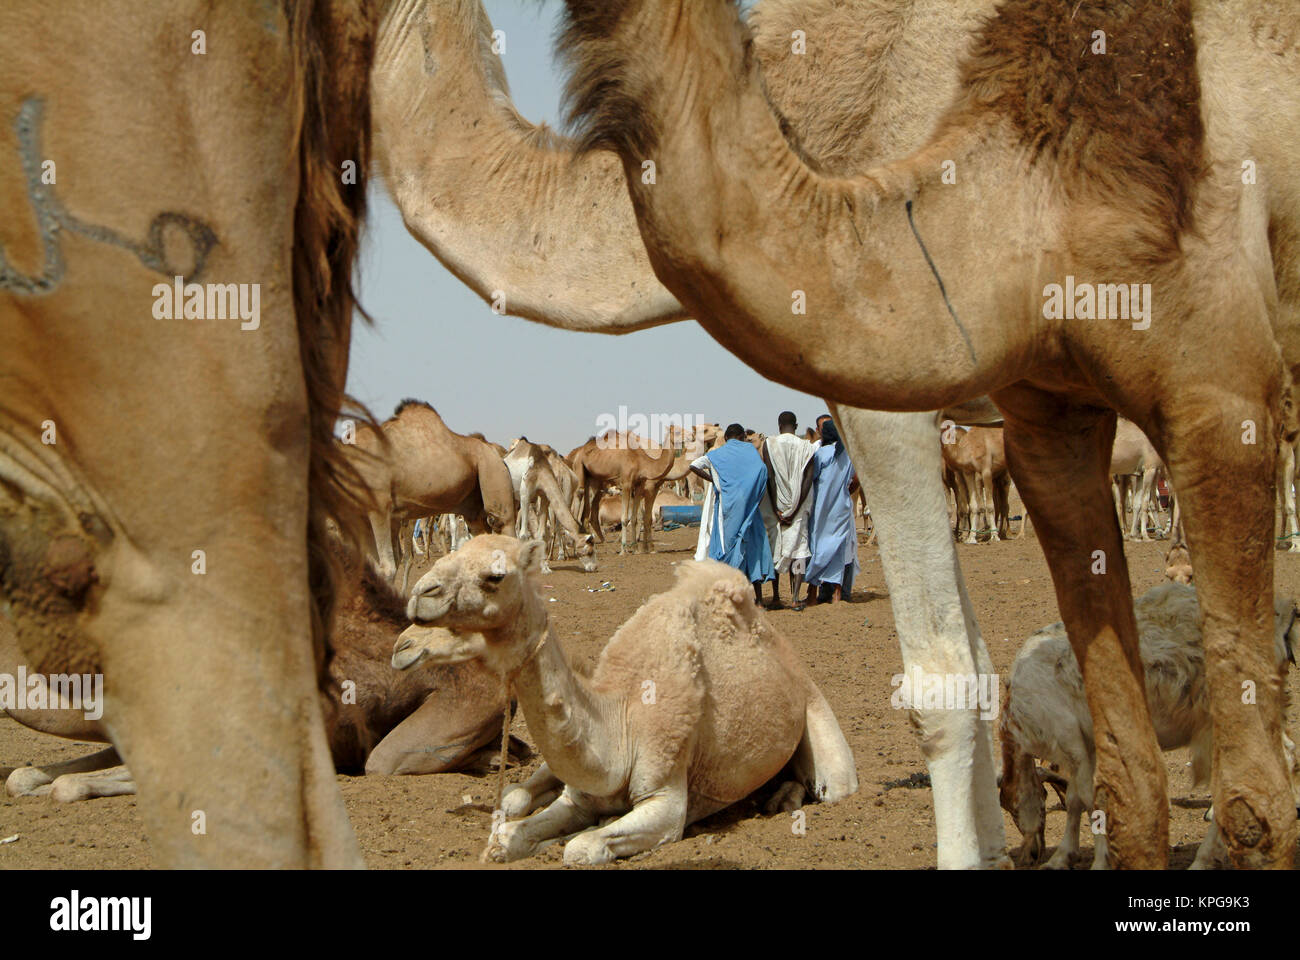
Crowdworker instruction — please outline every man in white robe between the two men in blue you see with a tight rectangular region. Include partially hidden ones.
[763,410,814,610]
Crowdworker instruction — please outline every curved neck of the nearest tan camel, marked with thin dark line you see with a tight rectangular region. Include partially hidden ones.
[566,0,1041,410]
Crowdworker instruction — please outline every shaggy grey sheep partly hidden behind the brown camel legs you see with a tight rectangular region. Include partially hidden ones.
[998,583,1300,870]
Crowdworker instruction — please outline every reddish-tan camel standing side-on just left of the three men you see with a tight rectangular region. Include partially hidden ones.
[569,431,675,553]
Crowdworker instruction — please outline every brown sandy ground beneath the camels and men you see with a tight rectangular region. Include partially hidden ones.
[0,515,1300,869]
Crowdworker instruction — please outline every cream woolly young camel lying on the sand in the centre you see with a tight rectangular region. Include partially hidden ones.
[393,536,858,864]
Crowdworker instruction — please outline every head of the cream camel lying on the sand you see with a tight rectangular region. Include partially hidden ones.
[393,535,546,673]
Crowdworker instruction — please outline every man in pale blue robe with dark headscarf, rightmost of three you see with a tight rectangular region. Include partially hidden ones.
[805,420,858,602]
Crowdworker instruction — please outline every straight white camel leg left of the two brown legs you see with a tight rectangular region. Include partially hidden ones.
[829,403,1010,869]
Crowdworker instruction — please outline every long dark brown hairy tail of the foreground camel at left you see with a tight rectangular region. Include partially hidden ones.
[285,0,376,679]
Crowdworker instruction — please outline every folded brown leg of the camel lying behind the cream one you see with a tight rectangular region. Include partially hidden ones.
[365,692,501,777]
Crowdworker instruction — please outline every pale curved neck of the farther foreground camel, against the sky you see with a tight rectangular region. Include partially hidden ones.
[371,0,685,332]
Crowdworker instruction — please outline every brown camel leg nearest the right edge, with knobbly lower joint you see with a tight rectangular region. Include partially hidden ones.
[1161,403,1296,868]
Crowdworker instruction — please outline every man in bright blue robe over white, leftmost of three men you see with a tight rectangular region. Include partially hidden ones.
[690,423,776,601]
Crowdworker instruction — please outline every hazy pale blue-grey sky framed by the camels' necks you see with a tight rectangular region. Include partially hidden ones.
[348,0,824,451]
